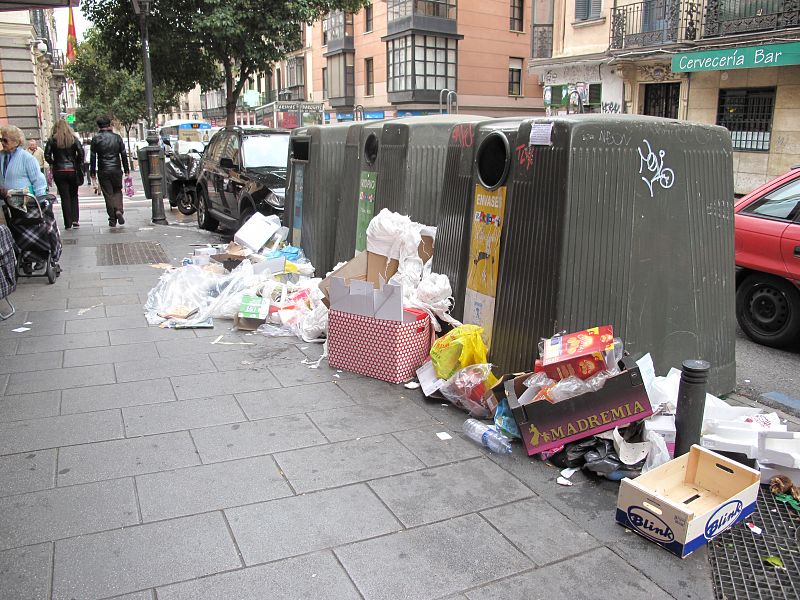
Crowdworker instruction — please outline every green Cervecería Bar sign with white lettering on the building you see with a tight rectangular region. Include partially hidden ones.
[672,42,800,73]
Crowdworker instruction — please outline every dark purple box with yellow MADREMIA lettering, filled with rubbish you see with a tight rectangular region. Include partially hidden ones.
[505,359,653,455]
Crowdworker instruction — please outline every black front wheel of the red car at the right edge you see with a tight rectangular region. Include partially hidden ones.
[736,273,800,348]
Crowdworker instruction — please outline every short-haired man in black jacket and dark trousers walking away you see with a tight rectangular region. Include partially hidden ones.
[89,117,128,227]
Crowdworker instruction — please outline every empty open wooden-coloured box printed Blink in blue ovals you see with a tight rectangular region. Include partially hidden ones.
[616,446,760,558]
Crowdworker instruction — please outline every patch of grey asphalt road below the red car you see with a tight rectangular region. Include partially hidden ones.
[736,327,800,415]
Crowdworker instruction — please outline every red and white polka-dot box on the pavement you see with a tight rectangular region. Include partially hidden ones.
[328,310,431,383]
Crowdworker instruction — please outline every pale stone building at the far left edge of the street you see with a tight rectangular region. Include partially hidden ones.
[0,9,64,140]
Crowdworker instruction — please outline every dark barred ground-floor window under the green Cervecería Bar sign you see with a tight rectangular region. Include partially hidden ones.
[717,88,775,152]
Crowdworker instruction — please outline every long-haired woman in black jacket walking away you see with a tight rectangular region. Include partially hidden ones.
[44,119,83,229]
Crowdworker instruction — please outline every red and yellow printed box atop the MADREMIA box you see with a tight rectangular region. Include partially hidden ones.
[541,325,614,381]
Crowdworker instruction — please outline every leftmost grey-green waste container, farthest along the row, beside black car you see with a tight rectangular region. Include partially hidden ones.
[284,123,353,276]
